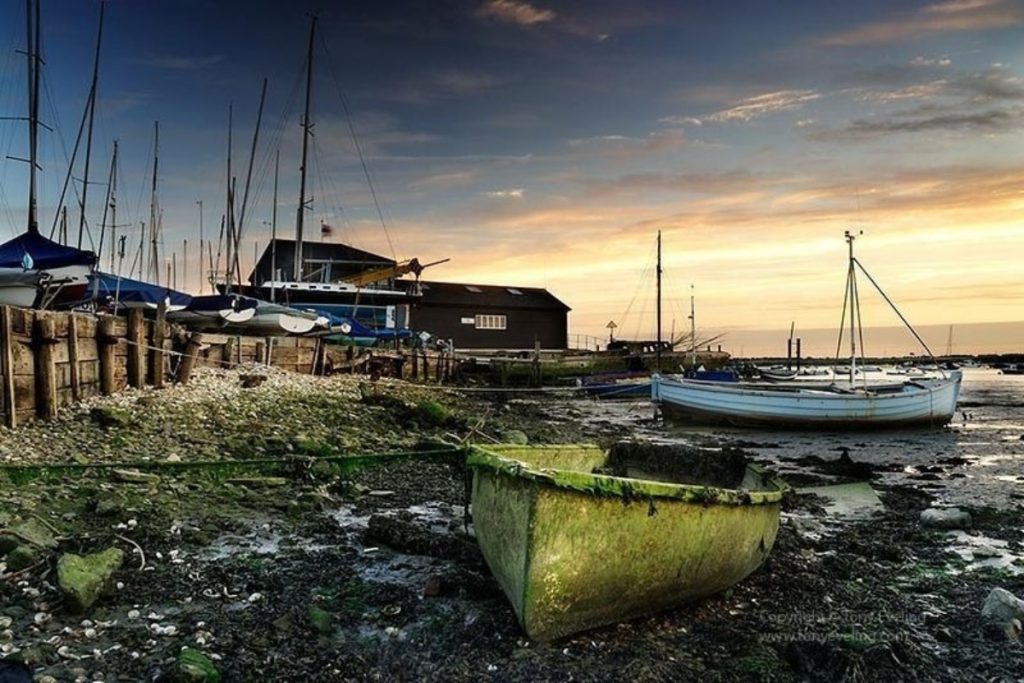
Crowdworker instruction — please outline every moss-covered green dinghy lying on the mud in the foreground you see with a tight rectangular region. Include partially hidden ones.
[467,444,784,640]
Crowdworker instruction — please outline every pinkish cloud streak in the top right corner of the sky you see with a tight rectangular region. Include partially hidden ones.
[819,0,1024,47]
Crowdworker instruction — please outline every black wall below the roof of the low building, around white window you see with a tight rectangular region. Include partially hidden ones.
[410,302,568,349]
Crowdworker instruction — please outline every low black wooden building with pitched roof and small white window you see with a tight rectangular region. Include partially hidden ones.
[410,282,570,350]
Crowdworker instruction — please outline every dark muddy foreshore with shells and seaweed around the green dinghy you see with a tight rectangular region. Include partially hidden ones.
[0,374,1024,681]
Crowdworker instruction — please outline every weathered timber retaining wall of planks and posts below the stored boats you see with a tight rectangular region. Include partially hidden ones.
[0,306,325,427]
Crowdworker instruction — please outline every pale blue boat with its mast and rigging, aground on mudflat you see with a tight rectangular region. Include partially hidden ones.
[651,231,962,429]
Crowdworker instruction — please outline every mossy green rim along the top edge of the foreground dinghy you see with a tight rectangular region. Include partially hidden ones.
[466,444,790,506]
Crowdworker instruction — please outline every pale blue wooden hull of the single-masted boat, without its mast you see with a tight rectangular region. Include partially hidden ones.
[651,371,961,429]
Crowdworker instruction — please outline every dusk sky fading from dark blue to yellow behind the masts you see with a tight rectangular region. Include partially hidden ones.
[0,0,1024,351]
